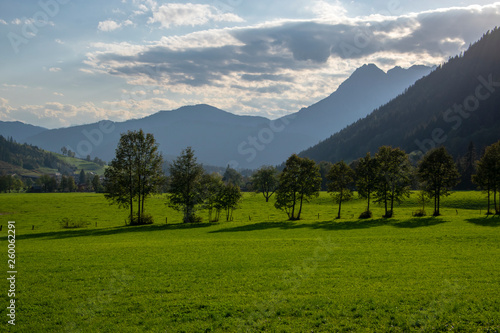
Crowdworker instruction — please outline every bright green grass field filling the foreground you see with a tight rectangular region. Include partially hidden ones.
[0,192,500,332]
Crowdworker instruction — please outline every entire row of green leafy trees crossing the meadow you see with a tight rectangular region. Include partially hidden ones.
[104,130,500,224]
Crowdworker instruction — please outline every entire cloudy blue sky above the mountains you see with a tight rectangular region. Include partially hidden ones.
[0,0,500,128]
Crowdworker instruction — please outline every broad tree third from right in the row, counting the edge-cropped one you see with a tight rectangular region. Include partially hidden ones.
[374,146,412,218]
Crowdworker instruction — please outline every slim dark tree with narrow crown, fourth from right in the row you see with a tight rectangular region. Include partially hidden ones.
[356,153,379,217]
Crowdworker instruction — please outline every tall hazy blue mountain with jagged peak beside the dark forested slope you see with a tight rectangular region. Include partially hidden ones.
[278,64,432,144]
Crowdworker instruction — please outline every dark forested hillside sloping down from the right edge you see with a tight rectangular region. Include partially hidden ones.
[301,29,500,162]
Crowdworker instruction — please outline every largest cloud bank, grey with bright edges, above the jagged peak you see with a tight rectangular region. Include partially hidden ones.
[80,1,500,116]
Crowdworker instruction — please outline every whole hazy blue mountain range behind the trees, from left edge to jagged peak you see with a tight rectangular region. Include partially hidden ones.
[0,64,432,168]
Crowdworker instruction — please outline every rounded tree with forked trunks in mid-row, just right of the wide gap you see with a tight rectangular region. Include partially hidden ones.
[274,154,321,220]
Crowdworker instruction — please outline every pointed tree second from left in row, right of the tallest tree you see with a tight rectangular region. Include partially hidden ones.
[168,147,203,223]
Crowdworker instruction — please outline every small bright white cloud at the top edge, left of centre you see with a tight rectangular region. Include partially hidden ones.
[148,3,244,28]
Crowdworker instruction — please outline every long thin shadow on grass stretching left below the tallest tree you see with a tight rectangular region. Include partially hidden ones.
[16,223,217,240]
